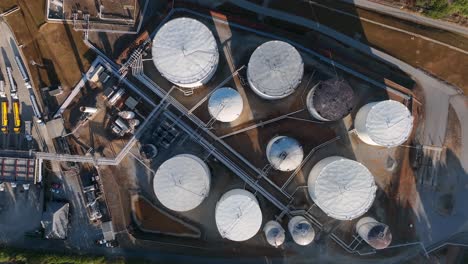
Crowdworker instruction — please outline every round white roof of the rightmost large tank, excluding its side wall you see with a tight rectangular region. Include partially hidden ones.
[366,100,413,147]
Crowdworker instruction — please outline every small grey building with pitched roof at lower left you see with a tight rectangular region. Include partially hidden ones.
[41,202,70,239]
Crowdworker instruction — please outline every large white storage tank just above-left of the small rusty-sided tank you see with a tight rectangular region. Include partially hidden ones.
[307,156,377,220]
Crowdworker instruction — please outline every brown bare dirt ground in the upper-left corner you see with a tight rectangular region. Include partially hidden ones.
[4,0,95,105]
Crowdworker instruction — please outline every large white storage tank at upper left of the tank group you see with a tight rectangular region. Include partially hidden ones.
[152,17,219,88]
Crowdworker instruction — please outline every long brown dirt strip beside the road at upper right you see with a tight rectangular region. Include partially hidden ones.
[270,1,468,92]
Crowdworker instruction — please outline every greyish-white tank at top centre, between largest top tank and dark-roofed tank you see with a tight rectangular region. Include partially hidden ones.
[247,40,304,100]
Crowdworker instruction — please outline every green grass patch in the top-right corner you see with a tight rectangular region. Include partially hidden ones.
[415,0,468,18]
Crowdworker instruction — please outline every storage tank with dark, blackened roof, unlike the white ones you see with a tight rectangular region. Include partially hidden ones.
[306,78,356,121]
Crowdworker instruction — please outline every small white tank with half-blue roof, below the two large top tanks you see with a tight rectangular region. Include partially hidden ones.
[208,87,244,122]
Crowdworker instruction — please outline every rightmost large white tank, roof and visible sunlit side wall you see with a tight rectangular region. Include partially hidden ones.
[354,100,413,147]
